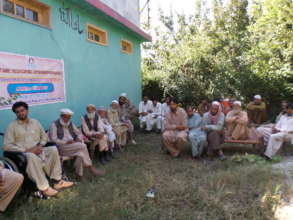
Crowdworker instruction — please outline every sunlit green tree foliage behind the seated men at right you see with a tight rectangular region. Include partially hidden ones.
[143,0,293,109]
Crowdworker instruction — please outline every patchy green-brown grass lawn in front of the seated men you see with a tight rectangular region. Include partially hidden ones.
[0,134,290,220]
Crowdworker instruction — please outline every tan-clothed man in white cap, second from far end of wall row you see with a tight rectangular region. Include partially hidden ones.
[108,100,128,150]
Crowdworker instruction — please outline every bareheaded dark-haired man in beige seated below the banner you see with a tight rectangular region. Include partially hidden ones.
[4,102,73,196]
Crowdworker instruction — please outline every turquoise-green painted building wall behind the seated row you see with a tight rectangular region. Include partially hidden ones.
[0,0,141,153]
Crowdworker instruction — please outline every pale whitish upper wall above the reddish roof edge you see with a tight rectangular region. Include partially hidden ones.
[101,0,140,26]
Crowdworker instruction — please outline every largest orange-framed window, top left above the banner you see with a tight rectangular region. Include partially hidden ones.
[0,0,50,27]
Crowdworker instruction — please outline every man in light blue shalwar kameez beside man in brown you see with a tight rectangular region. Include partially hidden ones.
[186,106,207,159]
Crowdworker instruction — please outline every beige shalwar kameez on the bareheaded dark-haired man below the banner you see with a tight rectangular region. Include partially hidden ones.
[3,119,62,191]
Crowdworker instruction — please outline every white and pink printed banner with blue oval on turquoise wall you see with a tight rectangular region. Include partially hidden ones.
[0,52,66,110]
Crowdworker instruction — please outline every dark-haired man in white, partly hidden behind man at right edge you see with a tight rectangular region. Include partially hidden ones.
[256,101,288,145]
